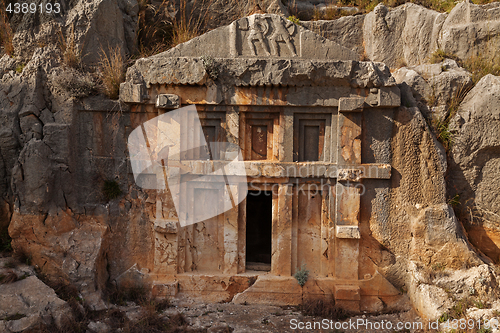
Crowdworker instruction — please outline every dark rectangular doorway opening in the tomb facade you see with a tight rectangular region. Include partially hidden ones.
[246,191,273,271]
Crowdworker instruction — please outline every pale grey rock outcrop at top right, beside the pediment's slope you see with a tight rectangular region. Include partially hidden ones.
[301,0,500,68]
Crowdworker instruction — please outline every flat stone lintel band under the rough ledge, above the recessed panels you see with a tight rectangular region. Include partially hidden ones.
[121,84,400,108]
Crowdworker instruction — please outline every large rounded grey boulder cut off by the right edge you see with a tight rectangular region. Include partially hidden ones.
[448,75,500,262]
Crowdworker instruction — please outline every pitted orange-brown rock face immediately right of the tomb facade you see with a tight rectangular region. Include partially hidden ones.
[367,107,483,318]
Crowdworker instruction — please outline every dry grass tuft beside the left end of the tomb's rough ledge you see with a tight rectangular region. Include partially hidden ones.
[99,47,125,99]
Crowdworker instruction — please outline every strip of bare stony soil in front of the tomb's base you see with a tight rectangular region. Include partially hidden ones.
[169,300,432,333]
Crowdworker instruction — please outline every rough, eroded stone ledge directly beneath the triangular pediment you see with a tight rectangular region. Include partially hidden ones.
[127,57,396,89]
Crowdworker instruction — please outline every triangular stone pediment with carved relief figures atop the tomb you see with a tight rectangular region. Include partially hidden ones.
[158,14,359,60]
